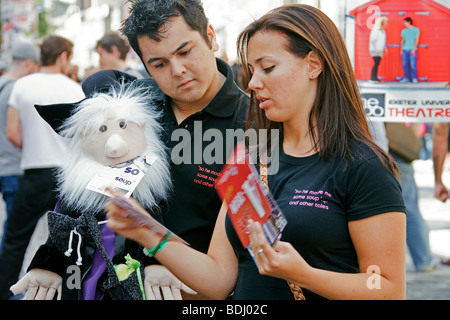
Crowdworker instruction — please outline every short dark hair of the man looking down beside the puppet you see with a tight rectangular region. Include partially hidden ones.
[120,0,210,58]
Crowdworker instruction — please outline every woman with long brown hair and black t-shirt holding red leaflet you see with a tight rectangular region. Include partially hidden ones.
[105,5,406,299]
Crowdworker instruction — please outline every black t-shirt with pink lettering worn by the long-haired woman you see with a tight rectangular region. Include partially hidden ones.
[226,144,406,300]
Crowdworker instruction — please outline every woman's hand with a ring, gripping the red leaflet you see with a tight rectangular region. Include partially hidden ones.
[248,221,311,286]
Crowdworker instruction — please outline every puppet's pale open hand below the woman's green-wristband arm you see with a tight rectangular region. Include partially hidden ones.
[144,265,197,300]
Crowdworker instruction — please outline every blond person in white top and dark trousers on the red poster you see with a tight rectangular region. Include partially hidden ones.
[369,17,389,83]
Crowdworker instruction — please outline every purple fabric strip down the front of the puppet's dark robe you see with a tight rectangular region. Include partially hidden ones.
[83,225,115,300]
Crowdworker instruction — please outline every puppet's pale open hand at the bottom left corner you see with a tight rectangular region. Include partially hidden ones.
[10,269,62,300]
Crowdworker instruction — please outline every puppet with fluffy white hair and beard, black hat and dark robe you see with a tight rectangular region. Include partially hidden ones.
[11,70,176,300]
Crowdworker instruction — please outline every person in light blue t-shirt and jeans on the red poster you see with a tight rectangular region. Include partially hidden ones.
[400,17,420,83]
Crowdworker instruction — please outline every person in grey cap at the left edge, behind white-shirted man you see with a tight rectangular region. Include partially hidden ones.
[0,41,41,251]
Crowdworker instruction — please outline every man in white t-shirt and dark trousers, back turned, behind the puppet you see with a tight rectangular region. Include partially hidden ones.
[0,36,84,299]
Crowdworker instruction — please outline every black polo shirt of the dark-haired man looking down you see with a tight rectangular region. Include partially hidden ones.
[145,59,248,252]
